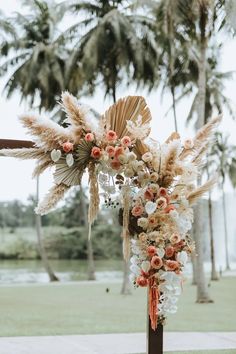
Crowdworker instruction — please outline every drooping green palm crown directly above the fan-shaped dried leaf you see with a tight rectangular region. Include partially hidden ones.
[60,0,157,102]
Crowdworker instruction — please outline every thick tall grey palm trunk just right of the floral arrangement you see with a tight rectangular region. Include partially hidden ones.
[194,28,212,303]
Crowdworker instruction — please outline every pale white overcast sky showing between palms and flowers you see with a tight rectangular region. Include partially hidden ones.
[0,0,236,202]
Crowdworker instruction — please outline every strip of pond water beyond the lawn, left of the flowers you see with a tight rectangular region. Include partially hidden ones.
[0,260,122,284]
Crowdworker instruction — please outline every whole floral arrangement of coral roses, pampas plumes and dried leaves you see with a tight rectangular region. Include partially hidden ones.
[2,92,221,329]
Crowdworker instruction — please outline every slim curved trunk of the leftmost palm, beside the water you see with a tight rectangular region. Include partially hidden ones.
[35,177,59,281]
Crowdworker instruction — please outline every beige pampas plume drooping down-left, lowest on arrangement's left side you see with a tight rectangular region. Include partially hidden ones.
[35,183,69,215]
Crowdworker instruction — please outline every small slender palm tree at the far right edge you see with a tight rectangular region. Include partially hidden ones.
[211,133,236,270]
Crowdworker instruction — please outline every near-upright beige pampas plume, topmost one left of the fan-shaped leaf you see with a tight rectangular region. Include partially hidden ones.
[61,92,86,143]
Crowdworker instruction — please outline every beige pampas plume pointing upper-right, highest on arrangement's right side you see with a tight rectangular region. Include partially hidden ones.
[180,115,222,160]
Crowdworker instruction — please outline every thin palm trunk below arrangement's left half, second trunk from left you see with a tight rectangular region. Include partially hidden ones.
[80,186,96,280]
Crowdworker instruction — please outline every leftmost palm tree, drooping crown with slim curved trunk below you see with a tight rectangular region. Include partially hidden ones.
[0,0,69,281]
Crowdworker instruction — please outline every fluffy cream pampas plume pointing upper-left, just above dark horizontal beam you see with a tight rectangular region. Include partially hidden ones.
[20,115,73,150]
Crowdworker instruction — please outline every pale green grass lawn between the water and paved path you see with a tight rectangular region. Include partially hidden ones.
[0,277,236,338]
